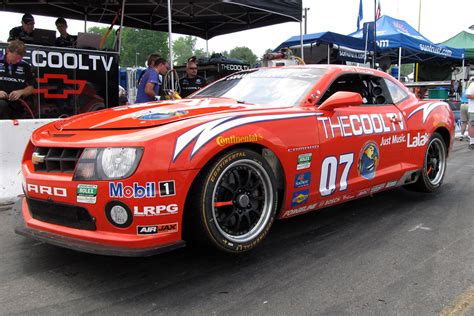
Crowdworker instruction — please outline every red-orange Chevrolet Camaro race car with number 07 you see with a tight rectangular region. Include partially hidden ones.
[16,65,455,256]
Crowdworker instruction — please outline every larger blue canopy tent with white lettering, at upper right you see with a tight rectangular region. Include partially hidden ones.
[349,15,464,79]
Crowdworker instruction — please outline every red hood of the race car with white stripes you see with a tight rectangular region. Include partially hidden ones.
[54,98,281,130]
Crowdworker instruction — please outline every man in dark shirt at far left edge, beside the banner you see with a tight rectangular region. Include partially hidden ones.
[0,40,35,119]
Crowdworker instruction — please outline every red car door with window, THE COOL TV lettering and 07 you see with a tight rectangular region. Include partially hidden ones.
[317,74,406,206]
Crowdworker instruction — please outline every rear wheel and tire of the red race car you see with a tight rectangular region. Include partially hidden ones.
[406,132,447,192]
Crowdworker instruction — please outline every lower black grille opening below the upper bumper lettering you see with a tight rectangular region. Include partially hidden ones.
[26,198,96,230]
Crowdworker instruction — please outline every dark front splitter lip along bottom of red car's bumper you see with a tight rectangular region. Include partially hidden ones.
[15,218,186,257]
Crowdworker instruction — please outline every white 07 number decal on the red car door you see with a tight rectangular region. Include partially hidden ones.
[319,153,354,196]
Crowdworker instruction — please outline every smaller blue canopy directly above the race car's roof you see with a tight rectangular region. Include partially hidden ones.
[273,32,365,64]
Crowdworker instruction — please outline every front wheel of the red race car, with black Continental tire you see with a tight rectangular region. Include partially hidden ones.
[189,149,278,253]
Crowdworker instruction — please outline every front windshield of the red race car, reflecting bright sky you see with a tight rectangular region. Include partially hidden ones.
[193,68,326,106]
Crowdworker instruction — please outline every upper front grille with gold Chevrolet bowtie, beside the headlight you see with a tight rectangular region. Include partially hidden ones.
[32,147,83,173]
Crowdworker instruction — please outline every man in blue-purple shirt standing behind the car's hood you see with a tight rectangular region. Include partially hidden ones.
[135,58,169,103]
